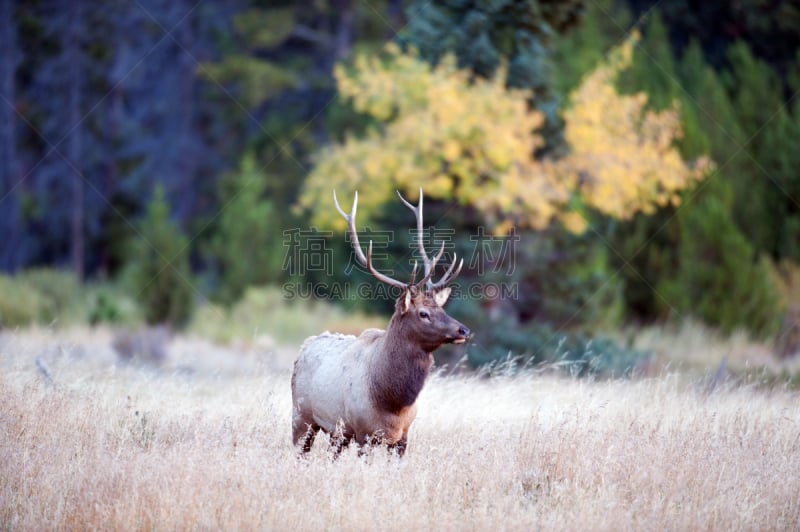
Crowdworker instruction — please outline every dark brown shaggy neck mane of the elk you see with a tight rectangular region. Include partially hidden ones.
[370,314,433,413]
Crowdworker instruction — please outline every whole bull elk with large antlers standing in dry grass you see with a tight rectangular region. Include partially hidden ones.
[292,189,470,456]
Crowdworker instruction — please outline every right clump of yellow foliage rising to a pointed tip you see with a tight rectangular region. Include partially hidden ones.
[564,39,711,219]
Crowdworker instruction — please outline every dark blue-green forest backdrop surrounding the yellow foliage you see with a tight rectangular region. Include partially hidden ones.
[0,0,800,363]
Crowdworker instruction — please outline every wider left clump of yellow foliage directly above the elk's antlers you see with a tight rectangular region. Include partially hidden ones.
[300,45,550,227]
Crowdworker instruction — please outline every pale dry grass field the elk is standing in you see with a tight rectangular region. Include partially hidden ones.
[0,329,800,531]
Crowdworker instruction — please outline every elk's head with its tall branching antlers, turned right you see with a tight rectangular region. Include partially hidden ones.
[333,187,470,353]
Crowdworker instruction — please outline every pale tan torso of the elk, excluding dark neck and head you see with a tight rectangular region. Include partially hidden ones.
[292,329,417,445]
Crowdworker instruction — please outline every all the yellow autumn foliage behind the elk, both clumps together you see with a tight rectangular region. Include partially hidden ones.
[299,40,711,233]
